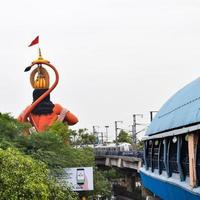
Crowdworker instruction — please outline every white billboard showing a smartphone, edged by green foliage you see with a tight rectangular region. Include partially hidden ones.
[62,167,94,191]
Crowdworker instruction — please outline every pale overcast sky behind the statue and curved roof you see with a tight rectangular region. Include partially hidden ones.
[0,0,200,141]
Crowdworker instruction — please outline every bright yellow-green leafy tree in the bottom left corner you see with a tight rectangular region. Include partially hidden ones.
[0,148,77,200]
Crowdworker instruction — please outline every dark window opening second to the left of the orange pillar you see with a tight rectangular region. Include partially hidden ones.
[169,137,178,175]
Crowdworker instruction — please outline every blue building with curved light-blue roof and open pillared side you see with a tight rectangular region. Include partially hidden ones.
[140,78,200,200]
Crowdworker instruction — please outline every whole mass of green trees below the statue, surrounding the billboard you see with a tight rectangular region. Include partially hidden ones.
[0,114,111,200]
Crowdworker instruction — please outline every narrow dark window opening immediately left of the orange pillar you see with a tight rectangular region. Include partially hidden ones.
[181,135,189,177]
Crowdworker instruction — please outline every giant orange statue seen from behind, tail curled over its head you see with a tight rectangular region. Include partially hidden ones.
[18,50,78,132]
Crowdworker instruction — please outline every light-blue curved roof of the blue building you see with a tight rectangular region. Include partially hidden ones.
[145,78,200,136]
